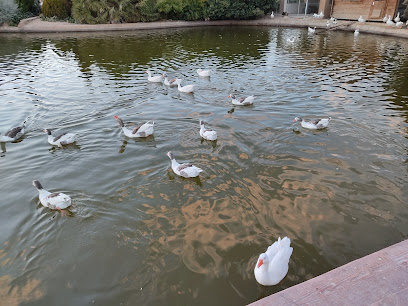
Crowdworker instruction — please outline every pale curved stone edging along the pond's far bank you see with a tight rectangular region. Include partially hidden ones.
[0,16,408,38]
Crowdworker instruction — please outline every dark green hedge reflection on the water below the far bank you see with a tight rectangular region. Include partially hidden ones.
[52,27,269,77]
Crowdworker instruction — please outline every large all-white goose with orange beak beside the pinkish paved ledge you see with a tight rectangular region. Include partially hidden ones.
[254,237,293,286]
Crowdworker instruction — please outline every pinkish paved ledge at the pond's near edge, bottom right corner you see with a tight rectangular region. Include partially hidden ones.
[250,240,408,306]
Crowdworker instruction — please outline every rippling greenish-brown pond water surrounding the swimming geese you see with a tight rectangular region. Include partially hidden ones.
[0,27,408,305]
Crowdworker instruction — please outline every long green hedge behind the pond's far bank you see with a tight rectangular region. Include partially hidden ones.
[72,0,278,23]
